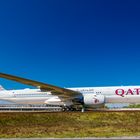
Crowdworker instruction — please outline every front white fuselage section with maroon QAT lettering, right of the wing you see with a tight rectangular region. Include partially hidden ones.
[70,86,140,103]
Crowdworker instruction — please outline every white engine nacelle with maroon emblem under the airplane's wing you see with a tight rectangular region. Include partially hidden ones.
[83,94,105,106]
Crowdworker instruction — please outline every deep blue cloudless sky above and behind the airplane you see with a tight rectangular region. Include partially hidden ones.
[0,0,140,89]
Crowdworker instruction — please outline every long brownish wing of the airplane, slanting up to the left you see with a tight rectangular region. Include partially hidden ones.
[0,73,81,99]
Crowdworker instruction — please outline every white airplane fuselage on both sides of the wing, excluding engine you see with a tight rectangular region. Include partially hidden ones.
[0,86,140,105]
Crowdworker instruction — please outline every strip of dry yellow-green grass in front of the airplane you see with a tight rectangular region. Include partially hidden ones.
[0,112,140,138]
